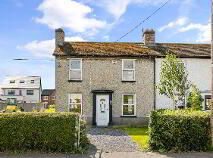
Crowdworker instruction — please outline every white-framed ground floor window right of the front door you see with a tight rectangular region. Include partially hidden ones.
[122,94,136,116]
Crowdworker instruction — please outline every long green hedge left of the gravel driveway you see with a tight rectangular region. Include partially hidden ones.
[0,113,88,153]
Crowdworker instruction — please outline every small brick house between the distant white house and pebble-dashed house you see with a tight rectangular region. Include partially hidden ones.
[41,89,55,107]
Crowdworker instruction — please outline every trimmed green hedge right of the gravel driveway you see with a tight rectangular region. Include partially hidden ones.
[149,110,211,151]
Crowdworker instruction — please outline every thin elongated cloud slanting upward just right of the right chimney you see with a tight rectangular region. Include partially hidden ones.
[158,17,188,32]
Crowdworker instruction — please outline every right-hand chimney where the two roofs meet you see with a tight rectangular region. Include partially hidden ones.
[143,29,155,45]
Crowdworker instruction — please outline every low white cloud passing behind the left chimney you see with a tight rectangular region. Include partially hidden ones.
[17,36,85,58]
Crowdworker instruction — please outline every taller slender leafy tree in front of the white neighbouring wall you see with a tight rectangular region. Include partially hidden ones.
[157,52,191,108]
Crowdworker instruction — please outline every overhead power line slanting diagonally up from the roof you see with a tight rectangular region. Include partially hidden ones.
[116,0,171,42]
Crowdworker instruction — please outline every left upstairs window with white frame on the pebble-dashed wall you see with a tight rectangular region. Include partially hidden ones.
[69,59,82,81]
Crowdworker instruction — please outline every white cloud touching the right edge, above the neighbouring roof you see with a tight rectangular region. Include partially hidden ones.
[177,23,211,43]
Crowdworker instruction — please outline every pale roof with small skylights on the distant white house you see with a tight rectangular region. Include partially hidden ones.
[1,76,41,89]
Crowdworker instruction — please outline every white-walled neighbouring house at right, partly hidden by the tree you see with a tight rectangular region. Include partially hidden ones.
[155,44,211,110]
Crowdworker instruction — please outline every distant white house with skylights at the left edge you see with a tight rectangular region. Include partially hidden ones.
[0,76,42,105]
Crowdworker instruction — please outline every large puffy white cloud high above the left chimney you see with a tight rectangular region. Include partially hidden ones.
[34,0,107,33]
